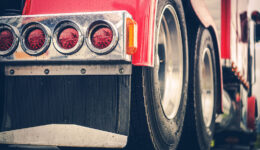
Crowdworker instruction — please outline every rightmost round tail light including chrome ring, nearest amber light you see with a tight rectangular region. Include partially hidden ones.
[87,21,118,54]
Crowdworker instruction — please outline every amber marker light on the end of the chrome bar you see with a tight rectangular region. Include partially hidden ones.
[126,18,137,55]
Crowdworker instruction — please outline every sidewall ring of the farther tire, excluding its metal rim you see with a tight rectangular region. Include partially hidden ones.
[194,27,217,150]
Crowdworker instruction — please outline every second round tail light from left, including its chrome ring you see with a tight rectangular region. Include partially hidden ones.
[21,23,50,56]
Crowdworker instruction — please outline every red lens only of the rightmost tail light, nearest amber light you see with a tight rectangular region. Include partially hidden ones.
[90,25,113,49]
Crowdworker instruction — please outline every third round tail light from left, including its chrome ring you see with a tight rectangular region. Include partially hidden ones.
[53,21,83,55]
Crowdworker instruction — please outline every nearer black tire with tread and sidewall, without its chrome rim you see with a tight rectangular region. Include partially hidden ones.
[127,0,188,150]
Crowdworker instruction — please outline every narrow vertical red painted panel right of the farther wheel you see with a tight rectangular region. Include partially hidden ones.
[221,0,231,59]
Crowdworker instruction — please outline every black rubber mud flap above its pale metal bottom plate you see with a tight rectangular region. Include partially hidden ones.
[0,75,131,135]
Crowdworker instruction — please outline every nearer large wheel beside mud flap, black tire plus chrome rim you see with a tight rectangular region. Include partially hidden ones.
[128,0,188,150]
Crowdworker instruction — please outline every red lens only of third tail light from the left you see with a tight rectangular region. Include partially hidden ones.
[58,27,79,49]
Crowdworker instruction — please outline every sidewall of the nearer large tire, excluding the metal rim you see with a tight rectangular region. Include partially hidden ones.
[144,0,188,149]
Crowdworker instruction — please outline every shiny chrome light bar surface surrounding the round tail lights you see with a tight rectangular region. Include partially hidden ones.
[0,11,131,62]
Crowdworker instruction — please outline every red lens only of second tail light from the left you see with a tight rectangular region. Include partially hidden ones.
[25,28,45,50]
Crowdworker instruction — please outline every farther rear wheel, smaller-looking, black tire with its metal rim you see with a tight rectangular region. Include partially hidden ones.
[179,26,217,150]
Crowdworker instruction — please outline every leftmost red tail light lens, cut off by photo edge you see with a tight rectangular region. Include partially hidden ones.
[0,29,14,51]
